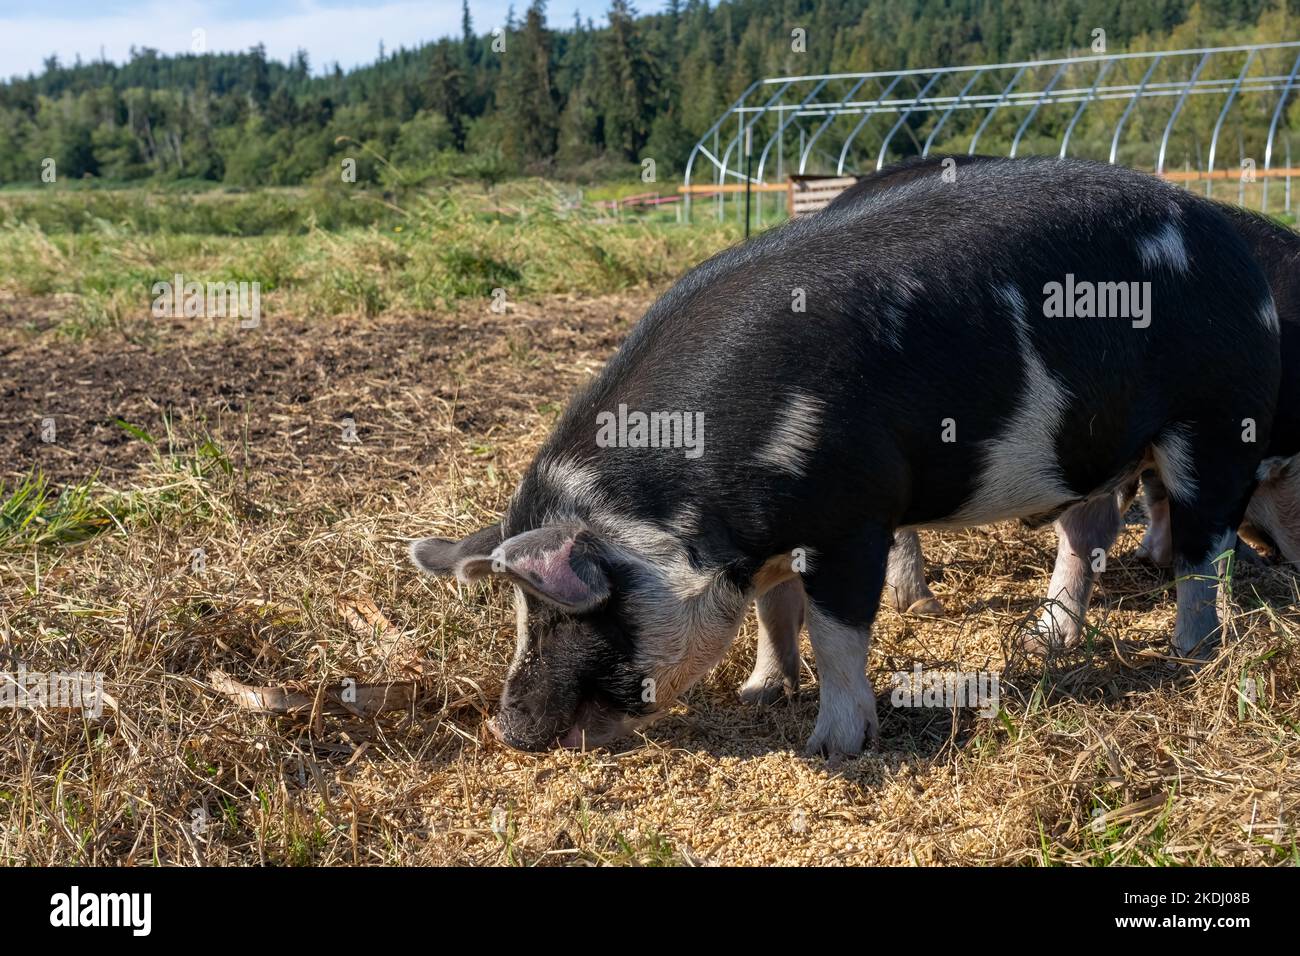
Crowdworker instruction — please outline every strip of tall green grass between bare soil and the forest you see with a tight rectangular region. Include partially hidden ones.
[0,183,740,327]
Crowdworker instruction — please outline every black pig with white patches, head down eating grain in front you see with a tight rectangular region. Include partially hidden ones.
[411,160,1278,754]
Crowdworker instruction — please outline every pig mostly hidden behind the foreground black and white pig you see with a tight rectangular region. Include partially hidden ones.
[828,156,1300,652]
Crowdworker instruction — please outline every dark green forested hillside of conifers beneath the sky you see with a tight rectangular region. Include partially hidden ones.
[0,0,1300,186]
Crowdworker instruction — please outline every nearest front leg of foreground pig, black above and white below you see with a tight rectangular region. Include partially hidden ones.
[803,528,893,758]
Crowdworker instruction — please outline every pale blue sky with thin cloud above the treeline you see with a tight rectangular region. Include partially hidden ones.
[0,0,664,77]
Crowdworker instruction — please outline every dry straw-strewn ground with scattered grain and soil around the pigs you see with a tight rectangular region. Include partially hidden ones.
[0,295,1300,865]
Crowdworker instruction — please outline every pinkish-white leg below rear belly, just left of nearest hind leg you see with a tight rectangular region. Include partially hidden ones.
[1031,494,1122,649]
